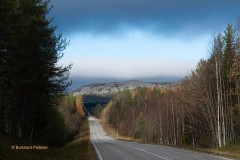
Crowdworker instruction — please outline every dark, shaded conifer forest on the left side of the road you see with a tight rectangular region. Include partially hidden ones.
[0,0,84,146]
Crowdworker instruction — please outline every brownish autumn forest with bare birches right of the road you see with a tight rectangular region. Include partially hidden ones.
[95,24,240,147]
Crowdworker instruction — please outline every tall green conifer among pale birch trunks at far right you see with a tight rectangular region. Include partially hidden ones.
[222,24,237,145]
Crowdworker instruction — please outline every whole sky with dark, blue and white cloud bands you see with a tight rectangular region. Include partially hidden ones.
[49,0,240,90]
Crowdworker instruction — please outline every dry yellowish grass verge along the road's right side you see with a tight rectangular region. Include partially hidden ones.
[98,119,240,160]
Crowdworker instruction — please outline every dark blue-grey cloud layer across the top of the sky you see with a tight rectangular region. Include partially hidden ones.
[51,0,240,34]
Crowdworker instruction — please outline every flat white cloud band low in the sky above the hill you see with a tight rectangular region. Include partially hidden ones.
[62,57,197,78]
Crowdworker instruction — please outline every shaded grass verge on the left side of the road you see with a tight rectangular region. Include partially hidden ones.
[0,120,97,160]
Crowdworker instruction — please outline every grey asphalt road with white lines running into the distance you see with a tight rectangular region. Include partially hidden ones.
[89,116,230,160]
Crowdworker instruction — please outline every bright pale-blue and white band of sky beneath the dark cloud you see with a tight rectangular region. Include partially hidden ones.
[60,31,210,78]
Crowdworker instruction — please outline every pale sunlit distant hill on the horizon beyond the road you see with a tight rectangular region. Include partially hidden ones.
[73,80,178,95]
